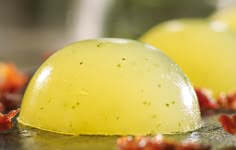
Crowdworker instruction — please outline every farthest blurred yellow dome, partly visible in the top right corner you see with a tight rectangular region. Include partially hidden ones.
[210,6,236,31]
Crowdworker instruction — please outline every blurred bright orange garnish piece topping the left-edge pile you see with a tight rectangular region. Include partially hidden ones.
[0,63,27,93]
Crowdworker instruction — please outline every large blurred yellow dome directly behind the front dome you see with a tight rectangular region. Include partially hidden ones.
[140,19,236,95]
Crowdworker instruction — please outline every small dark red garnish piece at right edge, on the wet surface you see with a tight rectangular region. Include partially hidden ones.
[219,114,236,134]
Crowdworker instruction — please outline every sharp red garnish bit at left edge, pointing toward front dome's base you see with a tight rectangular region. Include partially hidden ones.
[0,108,20,131]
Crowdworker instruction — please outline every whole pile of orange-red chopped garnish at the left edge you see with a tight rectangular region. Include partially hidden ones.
[0,62,28,131]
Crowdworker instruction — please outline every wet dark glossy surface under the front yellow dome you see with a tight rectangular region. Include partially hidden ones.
[0,113,236,150]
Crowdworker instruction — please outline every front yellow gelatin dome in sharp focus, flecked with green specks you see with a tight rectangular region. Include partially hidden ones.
[18,39,201,135]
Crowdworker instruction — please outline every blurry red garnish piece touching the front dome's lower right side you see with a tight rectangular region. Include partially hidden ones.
[195,88,218,113]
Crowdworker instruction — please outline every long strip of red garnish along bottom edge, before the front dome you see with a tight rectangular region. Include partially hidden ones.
[117,135,211,150]
